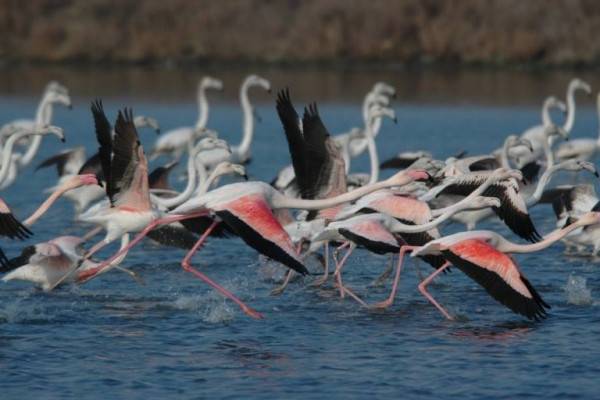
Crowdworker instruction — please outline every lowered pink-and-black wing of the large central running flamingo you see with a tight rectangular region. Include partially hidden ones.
[214,195,308,275]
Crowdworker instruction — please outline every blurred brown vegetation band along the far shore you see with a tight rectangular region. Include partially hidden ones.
[0,0,600,66]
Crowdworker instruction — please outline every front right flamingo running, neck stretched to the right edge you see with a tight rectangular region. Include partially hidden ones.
[399,212,600,321]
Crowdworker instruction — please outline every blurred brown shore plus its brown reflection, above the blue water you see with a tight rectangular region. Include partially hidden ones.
[0,0,600,105]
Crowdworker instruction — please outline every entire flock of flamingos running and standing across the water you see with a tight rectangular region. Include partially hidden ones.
[0,75,600,320]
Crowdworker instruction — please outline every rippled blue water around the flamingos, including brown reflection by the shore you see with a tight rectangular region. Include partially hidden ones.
[0,69,600,399]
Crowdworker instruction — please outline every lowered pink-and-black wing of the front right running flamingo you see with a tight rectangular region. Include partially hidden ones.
[442,239,550,321]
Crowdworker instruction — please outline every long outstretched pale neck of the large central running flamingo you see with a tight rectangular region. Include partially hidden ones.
[271,176,413,210]
